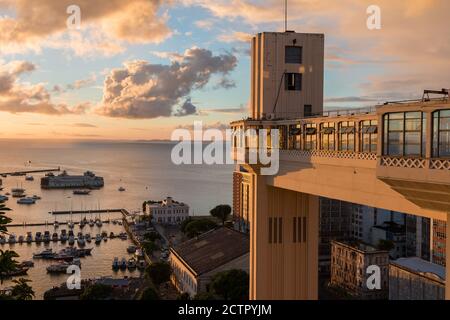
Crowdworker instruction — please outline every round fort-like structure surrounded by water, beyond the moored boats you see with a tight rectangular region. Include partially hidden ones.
[41,171,104,189]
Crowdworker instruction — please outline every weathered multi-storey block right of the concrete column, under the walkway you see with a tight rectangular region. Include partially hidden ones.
[330,241,389,300]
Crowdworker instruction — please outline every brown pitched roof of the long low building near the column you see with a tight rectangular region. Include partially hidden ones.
[171,227,250,275]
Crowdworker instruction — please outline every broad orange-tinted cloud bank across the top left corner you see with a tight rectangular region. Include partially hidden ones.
[0,0,171,52]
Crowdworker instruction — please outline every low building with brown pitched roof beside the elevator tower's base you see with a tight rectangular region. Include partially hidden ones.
[169,227,249,297]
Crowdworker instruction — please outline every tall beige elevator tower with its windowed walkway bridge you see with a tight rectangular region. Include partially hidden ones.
[231,32,450,299]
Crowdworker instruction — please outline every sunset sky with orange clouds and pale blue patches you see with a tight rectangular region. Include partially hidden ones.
[0,0,450,139]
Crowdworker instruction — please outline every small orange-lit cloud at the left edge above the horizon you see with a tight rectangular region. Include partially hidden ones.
[0,61,90,115]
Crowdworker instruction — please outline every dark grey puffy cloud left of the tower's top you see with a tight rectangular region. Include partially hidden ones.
[97,47,237,119]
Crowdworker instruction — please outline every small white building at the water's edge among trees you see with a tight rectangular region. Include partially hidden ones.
[145,197,189,224]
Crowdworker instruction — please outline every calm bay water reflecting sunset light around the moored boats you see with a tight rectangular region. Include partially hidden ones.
[0,140,233,298]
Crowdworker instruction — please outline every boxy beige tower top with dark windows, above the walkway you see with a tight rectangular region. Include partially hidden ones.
[251,32,324,119]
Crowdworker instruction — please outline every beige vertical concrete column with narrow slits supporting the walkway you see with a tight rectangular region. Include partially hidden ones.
[250,175,319,300]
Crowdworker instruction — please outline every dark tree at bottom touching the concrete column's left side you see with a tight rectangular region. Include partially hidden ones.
[210,269,249,300]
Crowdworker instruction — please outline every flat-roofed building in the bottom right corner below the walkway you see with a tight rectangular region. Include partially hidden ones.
[389,257,445,300]
